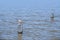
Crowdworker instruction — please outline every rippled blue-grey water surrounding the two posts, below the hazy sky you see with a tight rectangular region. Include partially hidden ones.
[0,9,60,40]
